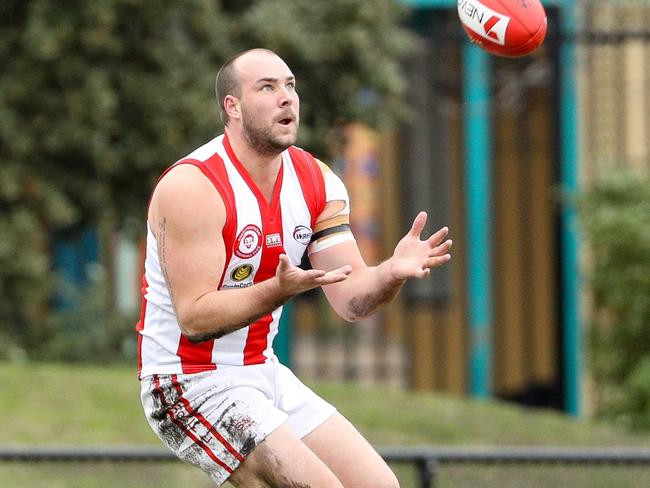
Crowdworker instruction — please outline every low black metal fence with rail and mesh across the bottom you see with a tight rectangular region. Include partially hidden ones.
[0,446,650,488]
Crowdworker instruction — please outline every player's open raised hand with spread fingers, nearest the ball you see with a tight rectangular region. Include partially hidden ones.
[391,212,452,280]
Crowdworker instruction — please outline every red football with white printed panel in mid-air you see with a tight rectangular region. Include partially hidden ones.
[458,0,546,57]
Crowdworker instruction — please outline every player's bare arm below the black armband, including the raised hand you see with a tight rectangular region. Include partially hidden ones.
[310,212,452,322]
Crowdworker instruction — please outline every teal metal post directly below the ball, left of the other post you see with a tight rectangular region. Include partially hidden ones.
[463,42,493,398]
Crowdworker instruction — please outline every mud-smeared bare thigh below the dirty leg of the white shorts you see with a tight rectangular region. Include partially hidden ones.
[229,425,348,488]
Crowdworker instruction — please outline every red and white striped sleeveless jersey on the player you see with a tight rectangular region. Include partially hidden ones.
[136,135,352,377]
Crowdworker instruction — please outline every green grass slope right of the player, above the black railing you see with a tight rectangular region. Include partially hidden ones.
[315,384,650,446]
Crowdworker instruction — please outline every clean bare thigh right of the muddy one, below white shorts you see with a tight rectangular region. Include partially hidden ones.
[302,413,399,488]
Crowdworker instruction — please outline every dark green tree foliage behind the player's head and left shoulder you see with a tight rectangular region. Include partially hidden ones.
[0,0,409,356]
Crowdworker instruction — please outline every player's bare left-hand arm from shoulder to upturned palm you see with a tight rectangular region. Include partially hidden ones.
[148,165,350,342]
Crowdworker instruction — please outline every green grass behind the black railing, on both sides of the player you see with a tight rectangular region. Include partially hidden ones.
[0,364,650,446]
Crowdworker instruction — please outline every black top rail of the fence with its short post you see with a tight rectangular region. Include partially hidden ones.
[0,446,650,488]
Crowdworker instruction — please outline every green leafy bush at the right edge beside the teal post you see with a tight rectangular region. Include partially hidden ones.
[581,174,650,429]
